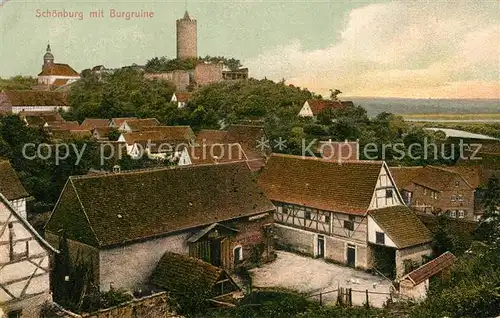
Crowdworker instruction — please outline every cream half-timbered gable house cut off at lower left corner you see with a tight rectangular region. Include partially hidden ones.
[0,191,57,318]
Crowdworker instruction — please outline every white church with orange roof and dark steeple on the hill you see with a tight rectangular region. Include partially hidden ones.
[38,45,80,87]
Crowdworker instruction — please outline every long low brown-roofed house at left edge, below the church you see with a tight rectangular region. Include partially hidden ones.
[0,90,69,114]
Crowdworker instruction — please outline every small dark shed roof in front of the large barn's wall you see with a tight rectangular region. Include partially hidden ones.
[151,252,238,299]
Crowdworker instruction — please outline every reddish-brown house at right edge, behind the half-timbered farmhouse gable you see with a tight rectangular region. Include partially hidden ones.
[391,166,498,221]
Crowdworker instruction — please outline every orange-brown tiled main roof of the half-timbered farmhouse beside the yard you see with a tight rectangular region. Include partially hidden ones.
[258,154,383,215]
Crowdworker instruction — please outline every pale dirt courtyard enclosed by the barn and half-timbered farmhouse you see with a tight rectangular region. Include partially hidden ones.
[250,251,391,307]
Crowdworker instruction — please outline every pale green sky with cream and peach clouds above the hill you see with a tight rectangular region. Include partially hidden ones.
[0,0,500,99]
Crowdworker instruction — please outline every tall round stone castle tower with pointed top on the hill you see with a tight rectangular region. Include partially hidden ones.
[177,11,198,59]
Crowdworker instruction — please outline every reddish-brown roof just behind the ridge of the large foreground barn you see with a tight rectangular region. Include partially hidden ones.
[188,144,248,165]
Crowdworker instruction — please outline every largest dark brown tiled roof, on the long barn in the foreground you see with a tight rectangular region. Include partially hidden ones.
[45,163,274,248]
